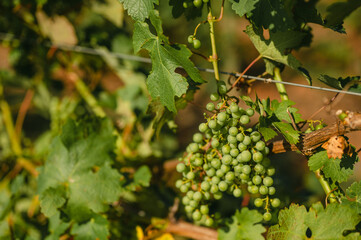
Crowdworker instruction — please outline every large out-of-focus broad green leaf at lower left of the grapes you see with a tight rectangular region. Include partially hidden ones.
[38,120,122,221]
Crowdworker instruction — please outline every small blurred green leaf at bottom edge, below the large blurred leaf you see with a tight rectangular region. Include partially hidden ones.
[71,215,109,240]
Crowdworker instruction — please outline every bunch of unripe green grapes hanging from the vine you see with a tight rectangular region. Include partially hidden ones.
[176,81,280,226]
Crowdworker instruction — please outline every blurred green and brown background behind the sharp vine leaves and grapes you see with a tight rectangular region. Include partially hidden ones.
[0,0,361,239]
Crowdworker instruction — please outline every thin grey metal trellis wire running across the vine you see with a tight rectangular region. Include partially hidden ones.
[0,33,361,97]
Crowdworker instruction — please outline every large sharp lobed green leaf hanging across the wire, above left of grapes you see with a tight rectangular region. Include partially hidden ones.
[133,15,203,112]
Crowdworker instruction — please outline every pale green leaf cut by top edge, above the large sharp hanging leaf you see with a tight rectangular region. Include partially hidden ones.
[119,0,159,21]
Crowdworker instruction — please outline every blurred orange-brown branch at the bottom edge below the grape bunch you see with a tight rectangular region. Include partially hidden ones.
[165,221,218,240]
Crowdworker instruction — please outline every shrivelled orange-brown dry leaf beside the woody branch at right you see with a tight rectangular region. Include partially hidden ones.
[322,136,351,159]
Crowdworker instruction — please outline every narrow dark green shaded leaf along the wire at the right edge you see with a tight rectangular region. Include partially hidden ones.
[318,75,361,92]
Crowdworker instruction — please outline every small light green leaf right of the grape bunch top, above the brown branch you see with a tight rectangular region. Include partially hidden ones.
[272,100,303,123]
